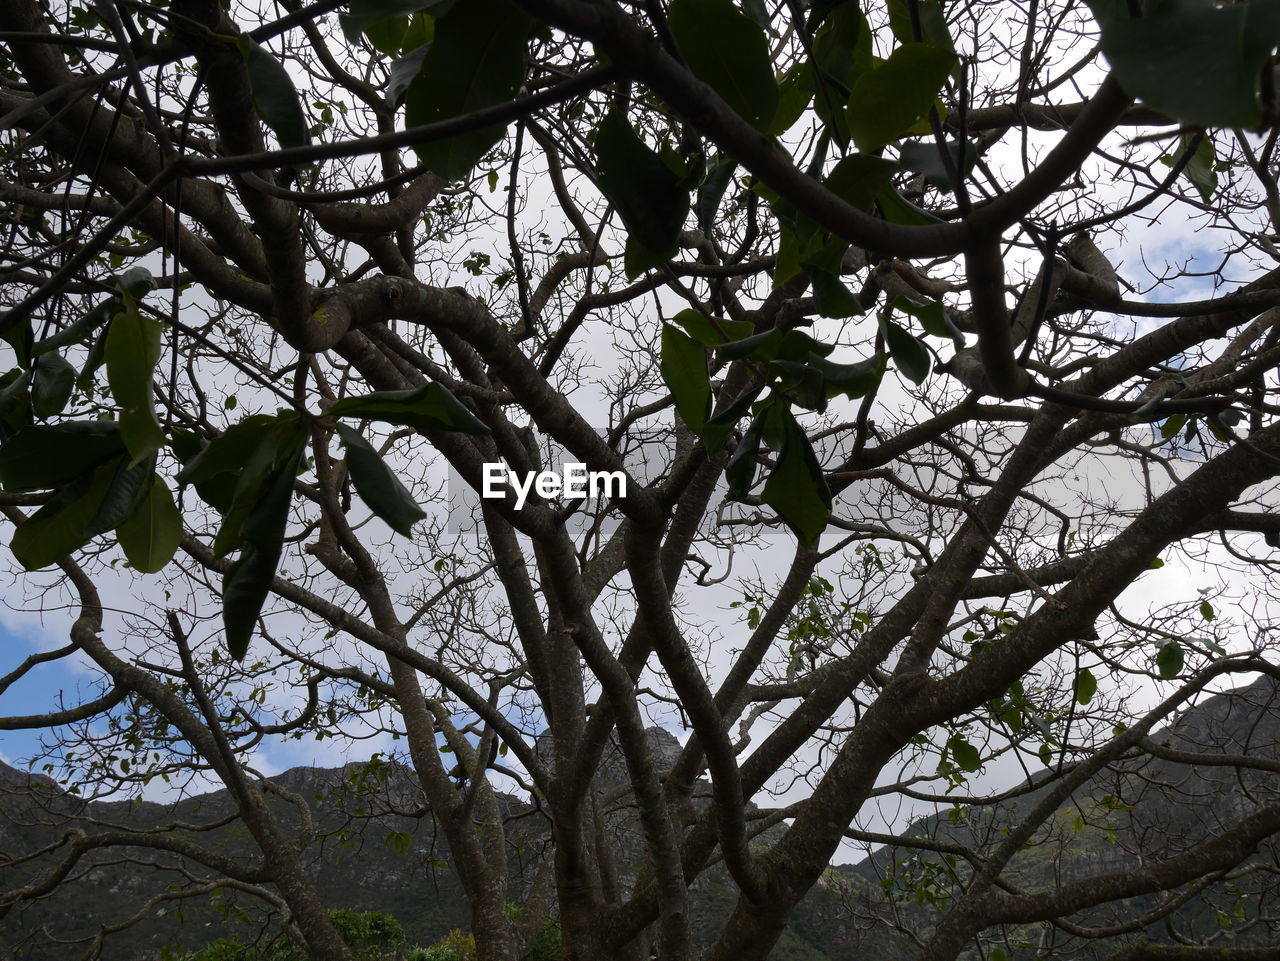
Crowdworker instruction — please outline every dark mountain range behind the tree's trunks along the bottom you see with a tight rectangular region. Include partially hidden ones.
[0,678,1280,961]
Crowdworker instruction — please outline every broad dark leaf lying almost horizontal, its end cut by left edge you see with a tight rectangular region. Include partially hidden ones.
[0,421,124,490]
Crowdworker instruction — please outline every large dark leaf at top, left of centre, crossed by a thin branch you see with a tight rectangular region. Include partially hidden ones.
[404,0,534,180]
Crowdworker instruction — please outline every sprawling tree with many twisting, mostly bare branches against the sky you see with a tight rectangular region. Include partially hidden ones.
[0,0,1280,961]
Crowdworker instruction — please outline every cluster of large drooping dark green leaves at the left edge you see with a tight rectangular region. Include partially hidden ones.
[0,277,488,659]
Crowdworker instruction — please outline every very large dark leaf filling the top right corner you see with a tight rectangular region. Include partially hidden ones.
[1089,0,1280,127]
